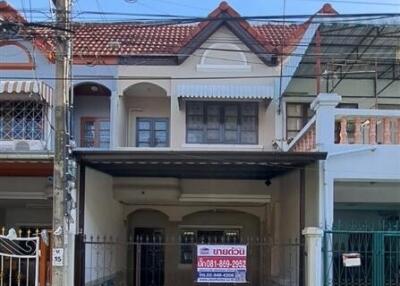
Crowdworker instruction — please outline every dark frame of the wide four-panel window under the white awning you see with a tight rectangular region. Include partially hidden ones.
[185,101,259,145]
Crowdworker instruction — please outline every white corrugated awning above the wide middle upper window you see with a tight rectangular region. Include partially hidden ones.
[175,84,274,108]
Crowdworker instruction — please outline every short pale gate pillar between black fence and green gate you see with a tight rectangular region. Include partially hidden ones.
[303,227,324,286]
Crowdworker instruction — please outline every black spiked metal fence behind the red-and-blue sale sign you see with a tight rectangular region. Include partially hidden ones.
[76,236,302,286]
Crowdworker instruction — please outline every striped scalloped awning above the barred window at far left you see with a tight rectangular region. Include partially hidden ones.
[0,80,53,106]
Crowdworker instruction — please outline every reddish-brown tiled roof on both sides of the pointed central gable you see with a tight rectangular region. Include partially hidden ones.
[0,2,333,61]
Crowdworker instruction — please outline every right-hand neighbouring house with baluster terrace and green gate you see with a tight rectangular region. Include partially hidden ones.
[282,17,400,285]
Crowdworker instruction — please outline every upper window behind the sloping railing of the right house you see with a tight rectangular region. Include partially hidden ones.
[286,102,313,138]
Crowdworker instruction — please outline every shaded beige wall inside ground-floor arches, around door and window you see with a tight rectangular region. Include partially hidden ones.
[128,210,260,286]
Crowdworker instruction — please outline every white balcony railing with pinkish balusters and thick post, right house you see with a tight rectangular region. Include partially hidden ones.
[287,94,400,152]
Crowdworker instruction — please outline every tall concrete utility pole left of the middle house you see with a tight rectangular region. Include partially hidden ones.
[51,0,70,286]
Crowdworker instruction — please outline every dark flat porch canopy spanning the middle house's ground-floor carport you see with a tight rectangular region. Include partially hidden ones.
[74,149,326,180]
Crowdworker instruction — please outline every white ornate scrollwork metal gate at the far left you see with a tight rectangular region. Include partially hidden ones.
[0,229,40,286]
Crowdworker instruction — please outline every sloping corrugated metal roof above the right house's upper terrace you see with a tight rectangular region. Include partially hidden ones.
[294,21,400,82]
